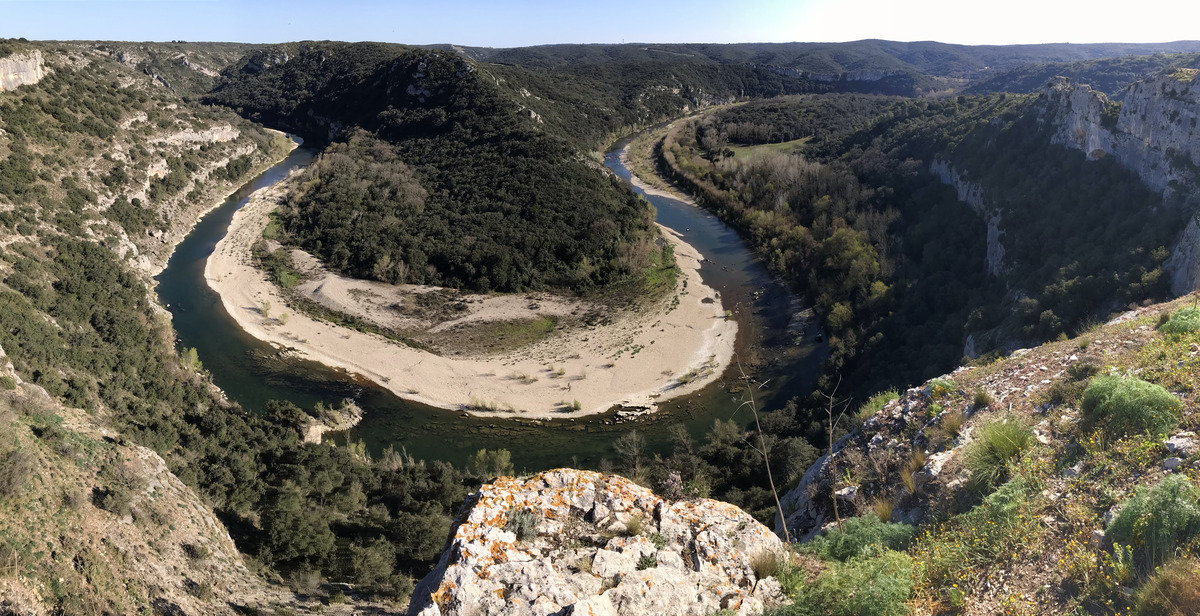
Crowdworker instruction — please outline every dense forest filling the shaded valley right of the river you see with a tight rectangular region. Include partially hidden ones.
[661,95,1183,390]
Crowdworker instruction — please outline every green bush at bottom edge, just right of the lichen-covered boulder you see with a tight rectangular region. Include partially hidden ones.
[764,550,912,616]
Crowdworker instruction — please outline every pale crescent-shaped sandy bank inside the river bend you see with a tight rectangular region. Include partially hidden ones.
[205,168,737,417]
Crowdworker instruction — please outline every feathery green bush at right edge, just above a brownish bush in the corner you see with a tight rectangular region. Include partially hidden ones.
[1105,474,1200,570]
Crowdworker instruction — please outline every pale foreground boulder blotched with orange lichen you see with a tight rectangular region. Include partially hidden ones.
[409,468,786,616]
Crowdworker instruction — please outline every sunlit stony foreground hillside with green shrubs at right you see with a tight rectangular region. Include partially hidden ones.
[778,298,1200,615]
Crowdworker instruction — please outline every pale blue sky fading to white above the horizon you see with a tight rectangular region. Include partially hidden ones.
[0,0,1200,47]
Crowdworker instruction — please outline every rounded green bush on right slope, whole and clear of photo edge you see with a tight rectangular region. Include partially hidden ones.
[1082,376,1180,436]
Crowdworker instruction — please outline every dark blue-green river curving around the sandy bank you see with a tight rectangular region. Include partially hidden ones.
[157,136,823,471]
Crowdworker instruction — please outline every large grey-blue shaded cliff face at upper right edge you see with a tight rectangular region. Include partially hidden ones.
[1042,70,1200,192]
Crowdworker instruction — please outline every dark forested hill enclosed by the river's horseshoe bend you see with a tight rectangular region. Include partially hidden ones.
[209,43,672,292]
